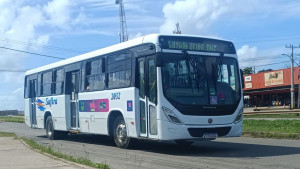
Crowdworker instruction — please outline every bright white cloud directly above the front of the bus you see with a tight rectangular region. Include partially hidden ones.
[160,0,229,34]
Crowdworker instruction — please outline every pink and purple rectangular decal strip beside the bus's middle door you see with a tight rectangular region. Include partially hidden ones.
[78,99,109,112]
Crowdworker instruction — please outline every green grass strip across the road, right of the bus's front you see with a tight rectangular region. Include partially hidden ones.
[243,120,300,139]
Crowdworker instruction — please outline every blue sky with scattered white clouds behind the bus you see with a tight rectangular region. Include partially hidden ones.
[0,0,300,110]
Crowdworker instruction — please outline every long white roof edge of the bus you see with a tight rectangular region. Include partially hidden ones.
[25,34,232,75]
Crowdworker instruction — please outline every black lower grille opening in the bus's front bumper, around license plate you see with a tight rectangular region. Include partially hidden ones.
[188,127,231,137]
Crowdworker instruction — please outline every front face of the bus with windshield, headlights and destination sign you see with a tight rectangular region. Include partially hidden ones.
[157,36,243,144]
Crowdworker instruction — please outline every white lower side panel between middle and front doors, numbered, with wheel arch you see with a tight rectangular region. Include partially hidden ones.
[79,87,136,137]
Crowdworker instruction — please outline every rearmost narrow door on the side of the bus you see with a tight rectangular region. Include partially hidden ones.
[29,80,37,128]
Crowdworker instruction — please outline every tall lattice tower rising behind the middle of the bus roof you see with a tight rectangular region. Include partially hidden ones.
[115,0,128,42]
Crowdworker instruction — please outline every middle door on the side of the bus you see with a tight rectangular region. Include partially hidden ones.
[66,71,79,130]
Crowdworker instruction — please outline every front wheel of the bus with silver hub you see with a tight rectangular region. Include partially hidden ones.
[113,116,130,149]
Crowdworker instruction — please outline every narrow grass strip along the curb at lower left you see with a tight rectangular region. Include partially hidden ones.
[22,138,110,169]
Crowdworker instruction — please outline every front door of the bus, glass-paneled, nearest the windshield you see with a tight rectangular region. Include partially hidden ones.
[138,57,157,138]
